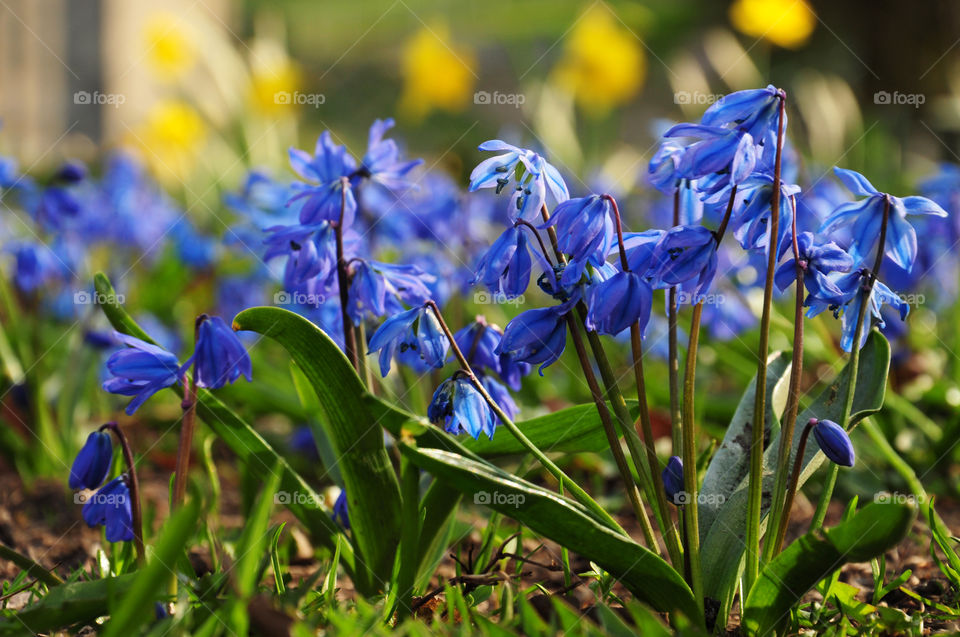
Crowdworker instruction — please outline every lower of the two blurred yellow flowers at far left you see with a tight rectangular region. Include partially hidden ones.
[133,100,207,180]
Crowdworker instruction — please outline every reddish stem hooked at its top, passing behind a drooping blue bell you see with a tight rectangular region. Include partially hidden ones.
[604,195,682,566]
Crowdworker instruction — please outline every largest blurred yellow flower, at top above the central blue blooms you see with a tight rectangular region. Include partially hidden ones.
[553,5,647,114]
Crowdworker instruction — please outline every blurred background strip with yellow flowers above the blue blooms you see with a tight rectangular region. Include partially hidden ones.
[0,0,960,195]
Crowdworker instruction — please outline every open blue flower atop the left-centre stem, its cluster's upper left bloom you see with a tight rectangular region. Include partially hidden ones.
[287,131,357,227]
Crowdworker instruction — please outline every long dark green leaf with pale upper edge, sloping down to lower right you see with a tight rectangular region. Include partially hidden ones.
[400,443,702,621]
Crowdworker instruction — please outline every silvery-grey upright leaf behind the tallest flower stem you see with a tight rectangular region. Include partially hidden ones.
[700,352,791,536]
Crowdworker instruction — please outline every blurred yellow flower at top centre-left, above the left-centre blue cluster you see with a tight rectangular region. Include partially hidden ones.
[399,24,476,119]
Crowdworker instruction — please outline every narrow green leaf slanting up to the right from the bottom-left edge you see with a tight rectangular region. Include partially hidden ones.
[103,500,200,637]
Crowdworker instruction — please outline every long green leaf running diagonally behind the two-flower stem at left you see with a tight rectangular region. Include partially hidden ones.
[94,273,354,573]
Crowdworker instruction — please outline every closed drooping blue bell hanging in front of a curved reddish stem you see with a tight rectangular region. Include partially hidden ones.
[585,272,653,336]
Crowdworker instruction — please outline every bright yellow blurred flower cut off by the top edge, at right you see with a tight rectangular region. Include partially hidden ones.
[730,0,817,49]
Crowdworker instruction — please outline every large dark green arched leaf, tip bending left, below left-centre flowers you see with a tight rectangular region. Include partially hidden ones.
[233,307,400,591]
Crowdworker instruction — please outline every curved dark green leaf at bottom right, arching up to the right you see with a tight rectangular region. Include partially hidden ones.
[743,502,917,635]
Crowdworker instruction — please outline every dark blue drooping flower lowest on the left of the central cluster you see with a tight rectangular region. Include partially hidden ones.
[497,299,575,376]
